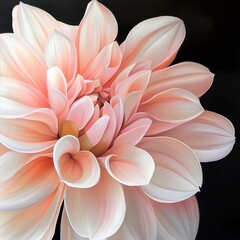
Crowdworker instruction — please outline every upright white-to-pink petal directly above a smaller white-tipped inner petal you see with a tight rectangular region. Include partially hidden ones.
[45,30,77,82]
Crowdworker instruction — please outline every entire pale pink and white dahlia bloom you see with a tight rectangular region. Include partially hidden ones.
[0,0,234,240]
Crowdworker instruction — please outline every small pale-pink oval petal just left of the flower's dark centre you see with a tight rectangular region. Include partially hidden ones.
[67,96,94,130]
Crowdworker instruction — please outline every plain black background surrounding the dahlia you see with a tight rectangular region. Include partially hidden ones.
[0,0,240,240]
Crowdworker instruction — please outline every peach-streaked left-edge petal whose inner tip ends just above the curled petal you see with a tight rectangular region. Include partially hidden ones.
[0,108,58,153]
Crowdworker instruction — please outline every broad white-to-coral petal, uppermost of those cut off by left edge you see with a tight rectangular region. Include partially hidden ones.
[0,33,47,96]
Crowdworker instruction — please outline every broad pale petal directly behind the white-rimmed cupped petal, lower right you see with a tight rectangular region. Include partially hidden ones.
[138,137,202,202]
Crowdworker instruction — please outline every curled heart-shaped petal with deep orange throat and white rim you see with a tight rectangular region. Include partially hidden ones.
[53,135,100,188]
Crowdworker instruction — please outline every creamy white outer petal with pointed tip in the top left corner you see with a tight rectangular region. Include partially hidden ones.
[12,2,76,53]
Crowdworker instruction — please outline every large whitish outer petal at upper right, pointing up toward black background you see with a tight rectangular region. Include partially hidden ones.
[120,16,185,69]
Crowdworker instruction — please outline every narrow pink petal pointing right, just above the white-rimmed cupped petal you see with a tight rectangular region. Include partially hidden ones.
[114,118,152,145]
